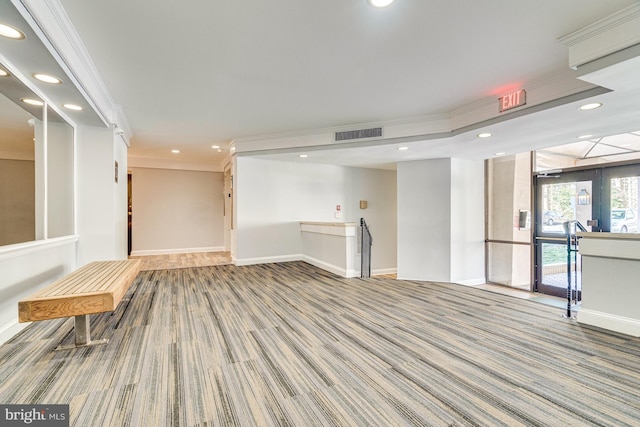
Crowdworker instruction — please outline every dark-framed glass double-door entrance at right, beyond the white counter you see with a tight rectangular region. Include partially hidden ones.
[534,164,640,299]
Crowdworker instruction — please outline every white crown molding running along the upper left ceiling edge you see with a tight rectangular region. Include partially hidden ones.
[18,0,132,141]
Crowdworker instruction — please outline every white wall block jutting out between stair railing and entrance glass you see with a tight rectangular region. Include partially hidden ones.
[398,159,484,284]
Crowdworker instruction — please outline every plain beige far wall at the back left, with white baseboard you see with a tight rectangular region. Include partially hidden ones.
[131,168,224,255]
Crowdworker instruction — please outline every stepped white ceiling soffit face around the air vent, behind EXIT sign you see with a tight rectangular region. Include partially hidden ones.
[233,4,640,159]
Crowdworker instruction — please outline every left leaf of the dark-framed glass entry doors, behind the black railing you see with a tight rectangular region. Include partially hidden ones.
[534,169,602,297]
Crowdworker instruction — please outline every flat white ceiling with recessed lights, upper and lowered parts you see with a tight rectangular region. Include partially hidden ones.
[31,0,640,167]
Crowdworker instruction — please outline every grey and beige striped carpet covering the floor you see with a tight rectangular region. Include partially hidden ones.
[0,262,640,427]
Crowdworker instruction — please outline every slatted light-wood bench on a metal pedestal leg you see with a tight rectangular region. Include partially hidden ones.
[18,259,140,349]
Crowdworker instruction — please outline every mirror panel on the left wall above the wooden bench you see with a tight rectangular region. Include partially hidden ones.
[0,69,74,246]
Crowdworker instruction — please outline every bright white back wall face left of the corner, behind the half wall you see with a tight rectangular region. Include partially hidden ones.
[234,157,347,264]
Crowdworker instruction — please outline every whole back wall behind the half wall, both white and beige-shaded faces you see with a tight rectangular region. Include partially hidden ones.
[233,157,396,272]
